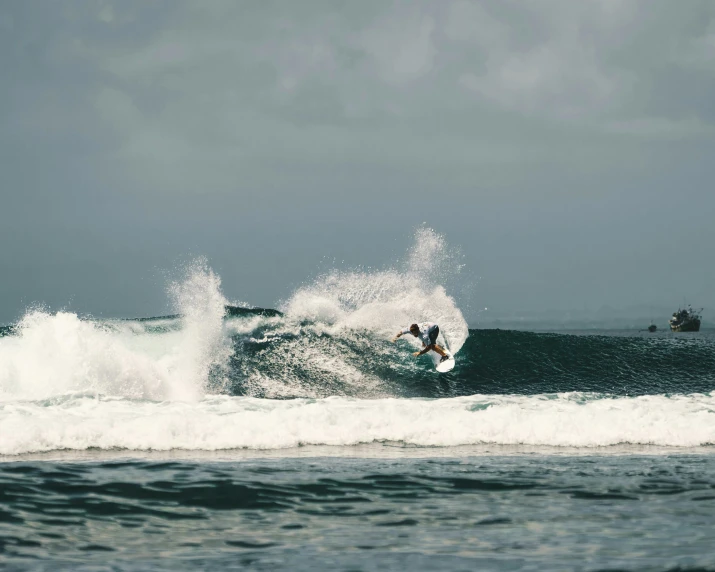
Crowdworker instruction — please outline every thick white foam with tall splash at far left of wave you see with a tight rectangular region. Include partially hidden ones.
[0,260,231,401]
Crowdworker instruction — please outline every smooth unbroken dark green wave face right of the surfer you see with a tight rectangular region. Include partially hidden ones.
[457,330,715,395]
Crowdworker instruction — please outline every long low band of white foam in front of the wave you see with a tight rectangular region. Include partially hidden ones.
[0,393,715,455]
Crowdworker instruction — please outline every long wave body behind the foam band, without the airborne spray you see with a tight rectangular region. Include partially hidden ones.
[0,308,715,401]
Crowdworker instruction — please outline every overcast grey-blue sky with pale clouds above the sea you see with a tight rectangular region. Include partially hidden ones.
[0,0,715,325]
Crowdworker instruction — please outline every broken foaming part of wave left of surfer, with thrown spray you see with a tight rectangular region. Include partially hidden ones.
[0,228,476,401]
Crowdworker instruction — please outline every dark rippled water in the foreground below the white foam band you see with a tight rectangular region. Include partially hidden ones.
[0,452,715,570]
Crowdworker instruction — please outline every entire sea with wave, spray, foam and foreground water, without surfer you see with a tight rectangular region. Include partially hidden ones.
[0,229,715,570]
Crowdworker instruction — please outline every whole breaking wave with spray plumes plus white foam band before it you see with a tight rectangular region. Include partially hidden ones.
[0,228,715,455]
